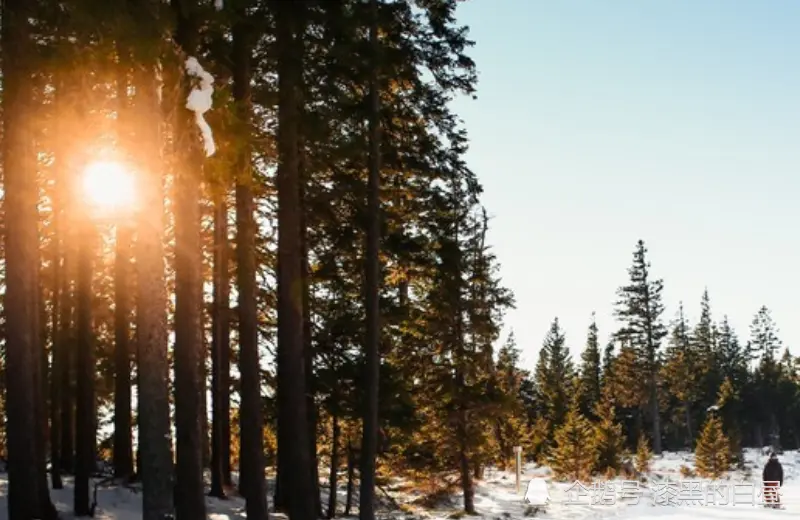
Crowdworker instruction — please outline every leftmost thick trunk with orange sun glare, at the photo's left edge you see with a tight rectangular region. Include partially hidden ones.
[2,5,42,504]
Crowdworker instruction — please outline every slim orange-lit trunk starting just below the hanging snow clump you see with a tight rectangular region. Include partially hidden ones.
[209,189,230,498]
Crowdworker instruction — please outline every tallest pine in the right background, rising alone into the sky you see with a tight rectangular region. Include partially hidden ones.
[615,240,667,454]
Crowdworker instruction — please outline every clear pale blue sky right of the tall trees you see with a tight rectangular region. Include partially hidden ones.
[454,0,800,367]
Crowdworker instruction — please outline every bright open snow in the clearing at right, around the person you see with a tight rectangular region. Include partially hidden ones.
[380,450,800,520]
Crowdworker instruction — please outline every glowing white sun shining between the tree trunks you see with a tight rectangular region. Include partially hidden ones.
[81,161,136,215]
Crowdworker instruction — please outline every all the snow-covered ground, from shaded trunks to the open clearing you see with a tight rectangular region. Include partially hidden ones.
[0,450,800,520]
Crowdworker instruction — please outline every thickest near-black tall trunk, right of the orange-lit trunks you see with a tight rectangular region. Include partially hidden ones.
[274,2,317,520]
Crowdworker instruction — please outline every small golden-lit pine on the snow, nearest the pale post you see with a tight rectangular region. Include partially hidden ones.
[548,399,597,481]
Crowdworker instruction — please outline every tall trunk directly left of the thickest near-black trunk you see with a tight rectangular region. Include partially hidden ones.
[233,9,270,520]
